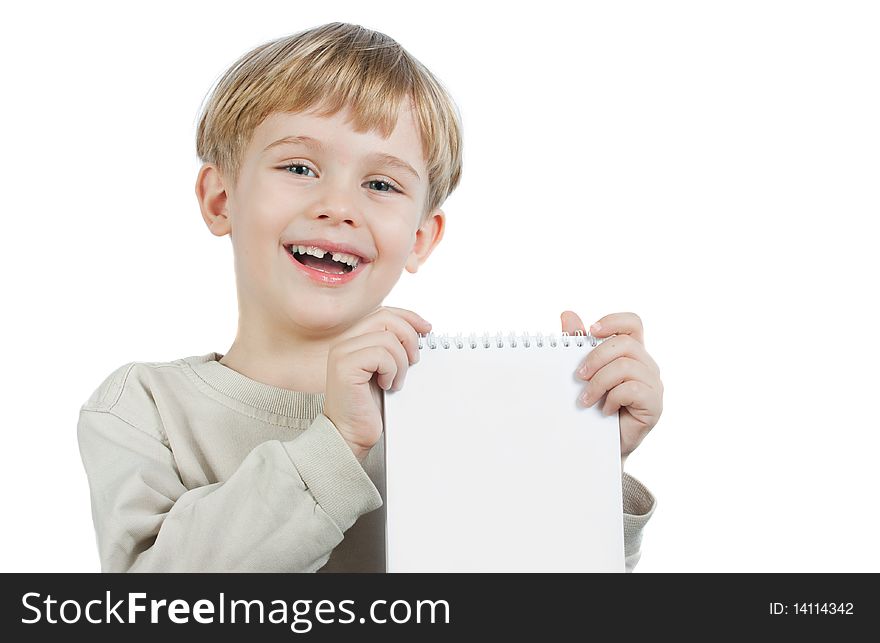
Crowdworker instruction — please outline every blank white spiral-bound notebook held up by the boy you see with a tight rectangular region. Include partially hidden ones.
[383,333,625,572]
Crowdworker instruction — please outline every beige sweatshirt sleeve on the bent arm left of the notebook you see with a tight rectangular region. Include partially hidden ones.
[77,407,382,572]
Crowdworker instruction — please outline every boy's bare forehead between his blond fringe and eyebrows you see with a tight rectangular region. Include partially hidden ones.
[249,102,425,171]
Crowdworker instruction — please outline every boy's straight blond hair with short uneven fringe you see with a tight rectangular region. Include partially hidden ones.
[196,22,462,225]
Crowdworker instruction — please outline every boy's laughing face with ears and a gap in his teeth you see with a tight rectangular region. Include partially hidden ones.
[197,102,444,338]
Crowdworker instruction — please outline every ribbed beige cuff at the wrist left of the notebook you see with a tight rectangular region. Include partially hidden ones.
[283,413,382,532]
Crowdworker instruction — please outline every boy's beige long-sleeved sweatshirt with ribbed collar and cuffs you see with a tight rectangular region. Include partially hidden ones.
[77,353,656,572]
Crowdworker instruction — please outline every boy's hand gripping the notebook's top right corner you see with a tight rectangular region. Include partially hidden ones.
[561,310,663,462]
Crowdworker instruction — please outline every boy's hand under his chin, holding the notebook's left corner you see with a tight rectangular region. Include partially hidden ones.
[324,306,431,461]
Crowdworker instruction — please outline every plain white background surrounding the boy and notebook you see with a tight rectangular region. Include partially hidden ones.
[0,0,880,572]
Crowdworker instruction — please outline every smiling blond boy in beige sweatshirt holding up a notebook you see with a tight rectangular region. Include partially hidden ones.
[78,23,659,572]
